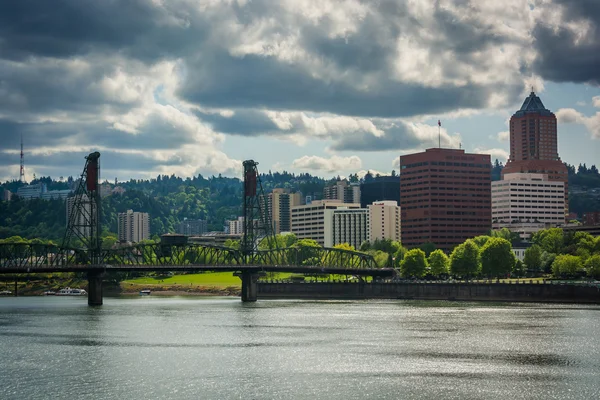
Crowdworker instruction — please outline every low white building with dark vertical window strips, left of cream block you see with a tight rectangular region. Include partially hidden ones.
[323,207,369,249]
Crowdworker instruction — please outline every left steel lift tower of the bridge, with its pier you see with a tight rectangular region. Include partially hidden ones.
[62,152,102,305]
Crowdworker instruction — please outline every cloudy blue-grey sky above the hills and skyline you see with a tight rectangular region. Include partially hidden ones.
[0,0,600,181]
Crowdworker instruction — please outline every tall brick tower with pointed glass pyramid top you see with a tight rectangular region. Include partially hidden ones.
[502,91,569,219]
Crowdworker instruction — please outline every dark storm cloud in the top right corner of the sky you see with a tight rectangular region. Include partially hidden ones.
[532,0,600,85]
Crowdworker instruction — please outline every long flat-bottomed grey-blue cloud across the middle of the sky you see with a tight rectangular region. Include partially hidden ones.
[180,53,492,117]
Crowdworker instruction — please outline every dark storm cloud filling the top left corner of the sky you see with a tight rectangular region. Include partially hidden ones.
[0,0,205,60]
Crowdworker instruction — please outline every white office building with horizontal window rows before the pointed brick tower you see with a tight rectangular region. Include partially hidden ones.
[492,173,565,239]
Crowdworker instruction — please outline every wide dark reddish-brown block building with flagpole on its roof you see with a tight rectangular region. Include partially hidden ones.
[400,148,492,249]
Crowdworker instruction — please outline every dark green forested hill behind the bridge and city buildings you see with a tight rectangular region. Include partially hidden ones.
[0,161,600,241]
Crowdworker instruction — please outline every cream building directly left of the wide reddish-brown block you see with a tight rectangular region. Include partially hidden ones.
[367,202,401,243]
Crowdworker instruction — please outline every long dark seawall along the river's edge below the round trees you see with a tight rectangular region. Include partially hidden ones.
[258,282,600,304]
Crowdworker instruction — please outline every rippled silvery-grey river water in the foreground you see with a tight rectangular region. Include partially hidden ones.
[0,296,600,400]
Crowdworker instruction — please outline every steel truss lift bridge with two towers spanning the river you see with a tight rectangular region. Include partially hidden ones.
[0,153,395,306]
